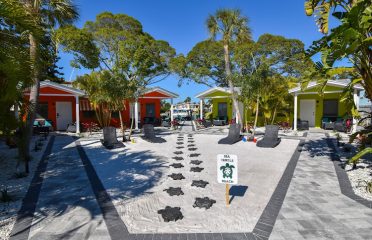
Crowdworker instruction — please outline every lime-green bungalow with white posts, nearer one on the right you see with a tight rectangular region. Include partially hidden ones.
[289,80,363,131]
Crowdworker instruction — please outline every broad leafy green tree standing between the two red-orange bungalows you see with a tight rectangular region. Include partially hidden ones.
[58,12,175,139]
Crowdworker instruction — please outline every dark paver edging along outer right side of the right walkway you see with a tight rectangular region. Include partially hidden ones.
[325,133,372,208]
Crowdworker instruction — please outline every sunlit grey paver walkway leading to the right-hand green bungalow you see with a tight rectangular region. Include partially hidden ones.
[270,133,372,240]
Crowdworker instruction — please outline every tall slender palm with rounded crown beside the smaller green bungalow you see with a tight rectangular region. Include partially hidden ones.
[207,9,251,126]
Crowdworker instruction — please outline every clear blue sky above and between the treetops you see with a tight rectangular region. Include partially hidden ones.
[59,0,370,102]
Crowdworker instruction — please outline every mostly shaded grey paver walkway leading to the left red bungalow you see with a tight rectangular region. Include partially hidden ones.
[29,136,110,240]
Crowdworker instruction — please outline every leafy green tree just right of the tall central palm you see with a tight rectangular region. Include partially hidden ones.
[232,34,314,131]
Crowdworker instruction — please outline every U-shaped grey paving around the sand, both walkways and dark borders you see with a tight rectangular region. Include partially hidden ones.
[7,133,372,240]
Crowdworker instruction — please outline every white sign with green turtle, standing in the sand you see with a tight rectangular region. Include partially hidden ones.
[217,154,238,184]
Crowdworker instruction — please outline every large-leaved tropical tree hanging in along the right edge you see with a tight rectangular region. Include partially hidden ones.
[305,0,372,167]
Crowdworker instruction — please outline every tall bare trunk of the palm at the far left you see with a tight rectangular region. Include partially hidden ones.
[18,34,40,173]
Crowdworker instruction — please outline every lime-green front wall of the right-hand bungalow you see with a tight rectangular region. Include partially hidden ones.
[297,93,348,128]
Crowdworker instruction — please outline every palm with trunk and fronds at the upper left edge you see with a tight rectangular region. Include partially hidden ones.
[20,0,79,173]
